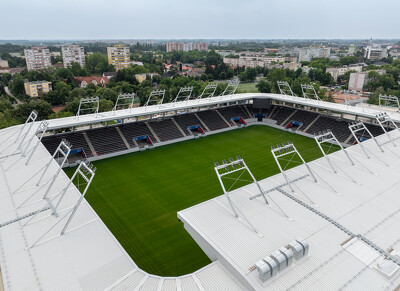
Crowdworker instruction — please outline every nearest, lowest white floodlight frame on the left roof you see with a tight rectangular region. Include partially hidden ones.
[27,161,96,249]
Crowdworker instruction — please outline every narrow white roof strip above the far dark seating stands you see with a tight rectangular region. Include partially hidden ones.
[43,93,400,129]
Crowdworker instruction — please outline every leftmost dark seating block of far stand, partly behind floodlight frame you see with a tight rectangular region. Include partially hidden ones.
[42,132,93,157]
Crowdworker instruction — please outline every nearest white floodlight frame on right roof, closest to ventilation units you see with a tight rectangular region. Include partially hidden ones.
[214,156,260,233]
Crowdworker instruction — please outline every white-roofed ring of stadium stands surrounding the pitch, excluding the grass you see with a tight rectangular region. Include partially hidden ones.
[0,93,400,290]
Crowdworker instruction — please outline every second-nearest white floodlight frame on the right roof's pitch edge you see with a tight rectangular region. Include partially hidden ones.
[271,141,317,192]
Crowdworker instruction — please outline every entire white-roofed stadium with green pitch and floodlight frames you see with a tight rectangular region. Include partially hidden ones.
[0,81,400,290]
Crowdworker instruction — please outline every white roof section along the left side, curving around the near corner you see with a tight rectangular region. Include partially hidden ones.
[0,116,242,290]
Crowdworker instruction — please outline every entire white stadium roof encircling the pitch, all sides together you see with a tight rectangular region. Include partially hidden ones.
[0,94,400,290]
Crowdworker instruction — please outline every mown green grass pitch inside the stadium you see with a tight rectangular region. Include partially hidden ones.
[67,125,334,276]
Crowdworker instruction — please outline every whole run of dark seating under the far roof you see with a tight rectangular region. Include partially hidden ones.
[39,105,390,157]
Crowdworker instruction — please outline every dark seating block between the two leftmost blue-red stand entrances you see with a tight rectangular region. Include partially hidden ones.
[86,126,127,155]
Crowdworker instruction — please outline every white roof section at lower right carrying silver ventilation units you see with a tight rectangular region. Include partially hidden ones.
[178,131,400,290]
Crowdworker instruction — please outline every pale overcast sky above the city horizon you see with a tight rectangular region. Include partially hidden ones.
[0,0,400,39]
